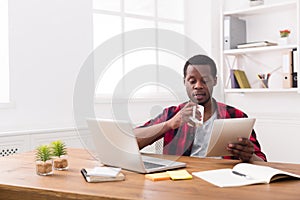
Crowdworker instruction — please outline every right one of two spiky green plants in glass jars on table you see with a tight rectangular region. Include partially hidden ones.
[50,140,68,170]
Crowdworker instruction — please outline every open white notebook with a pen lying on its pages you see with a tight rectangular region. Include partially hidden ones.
[192,163,300,187]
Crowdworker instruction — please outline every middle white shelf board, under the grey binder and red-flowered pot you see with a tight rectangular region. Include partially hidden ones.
[223,44,297,55]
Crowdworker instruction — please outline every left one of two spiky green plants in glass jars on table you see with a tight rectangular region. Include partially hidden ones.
[36,145,53,176]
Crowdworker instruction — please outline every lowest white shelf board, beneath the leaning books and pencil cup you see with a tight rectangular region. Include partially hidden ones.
[224,88,298,94]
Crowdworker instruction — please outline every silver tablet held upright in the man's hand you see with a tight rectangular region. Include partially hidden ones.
[206,118,255,157]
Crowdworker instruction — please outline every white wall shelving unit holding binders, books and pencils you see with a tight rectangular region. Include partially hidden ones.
[220,1,300,93]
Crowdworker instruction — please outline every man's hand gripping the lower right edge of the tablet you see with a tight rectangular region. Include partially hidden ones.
[227,138,257,162]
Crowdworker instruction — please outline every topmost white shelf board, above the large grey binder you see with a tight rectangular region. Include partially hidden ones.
[223,1,297,17]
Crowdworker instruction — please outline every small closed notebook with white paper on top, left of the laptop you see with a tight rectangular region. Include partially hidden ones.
[80,167,125,183]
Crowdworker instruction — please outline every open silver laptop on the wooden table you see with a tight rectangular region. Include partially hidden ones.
[87,119,186,173]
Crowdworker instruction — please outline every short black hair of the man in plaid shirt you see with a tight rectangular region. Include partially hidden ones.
[183,55,217,78]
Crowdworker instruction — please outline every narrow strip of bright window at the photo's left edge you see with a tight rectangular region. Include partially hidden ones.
[0,0,9,103]
